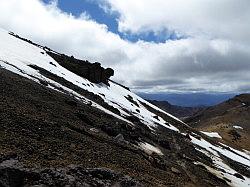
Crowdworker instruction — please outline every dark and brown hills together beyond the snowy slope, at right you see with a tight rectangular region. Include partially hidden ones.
[148,94,250,153]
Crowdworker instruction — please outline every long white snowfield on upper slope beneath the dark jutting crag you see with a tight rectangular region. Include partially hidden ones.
[0,30,180,131]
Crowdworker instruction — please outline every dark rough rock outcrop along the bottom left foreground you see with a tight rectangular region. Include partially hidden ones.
[0,159,142,187]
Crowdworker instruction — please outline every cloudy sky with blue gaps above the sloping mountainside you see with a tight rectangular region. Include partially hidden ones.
[0,0,250,96]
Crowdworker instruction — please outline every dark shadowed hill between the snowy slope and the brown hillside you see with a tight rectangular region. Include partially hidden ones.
[147,100,206,119]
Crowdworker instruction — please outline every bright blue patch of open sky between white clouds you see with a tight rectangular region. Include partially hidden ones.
[43,0,181,43]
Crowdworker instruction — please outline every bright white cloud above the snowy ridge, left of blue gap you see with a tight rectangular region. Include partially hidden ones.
[0,0,129,65]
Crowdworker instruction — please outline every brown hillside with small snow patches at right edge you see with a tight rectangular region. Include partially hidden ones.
[186,94,250,150]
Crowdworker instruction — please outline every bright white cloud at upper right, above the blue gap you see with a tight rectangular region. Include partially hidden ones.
[103,0,250,41]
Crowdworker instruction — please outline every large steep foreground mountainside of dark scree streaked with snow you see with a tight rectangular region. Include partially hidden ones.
[0,30,250,186]
